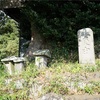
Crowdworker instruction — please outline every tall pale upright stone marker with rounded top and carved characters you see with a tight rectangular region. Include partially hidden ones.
[78,28,95,64]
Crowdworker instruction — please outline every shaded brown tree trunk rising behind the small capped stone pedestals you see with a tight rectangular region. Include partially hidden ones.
[26,23,43,58]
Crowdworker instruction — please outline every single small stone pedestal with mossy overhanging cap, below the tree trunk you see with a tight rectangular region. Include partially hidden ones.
[33,49,51,68]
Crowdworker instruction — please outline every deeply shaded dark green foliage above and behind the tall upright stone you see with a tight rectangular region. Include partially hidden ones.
[22,0,100,50]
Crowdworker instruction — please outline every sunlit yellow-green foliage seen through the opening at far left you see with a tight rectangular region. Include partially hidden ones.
[0,11,19,63]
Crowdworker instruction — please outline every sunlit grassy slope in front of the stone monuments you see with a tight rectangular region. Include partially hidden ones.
[0,59,100,100]
